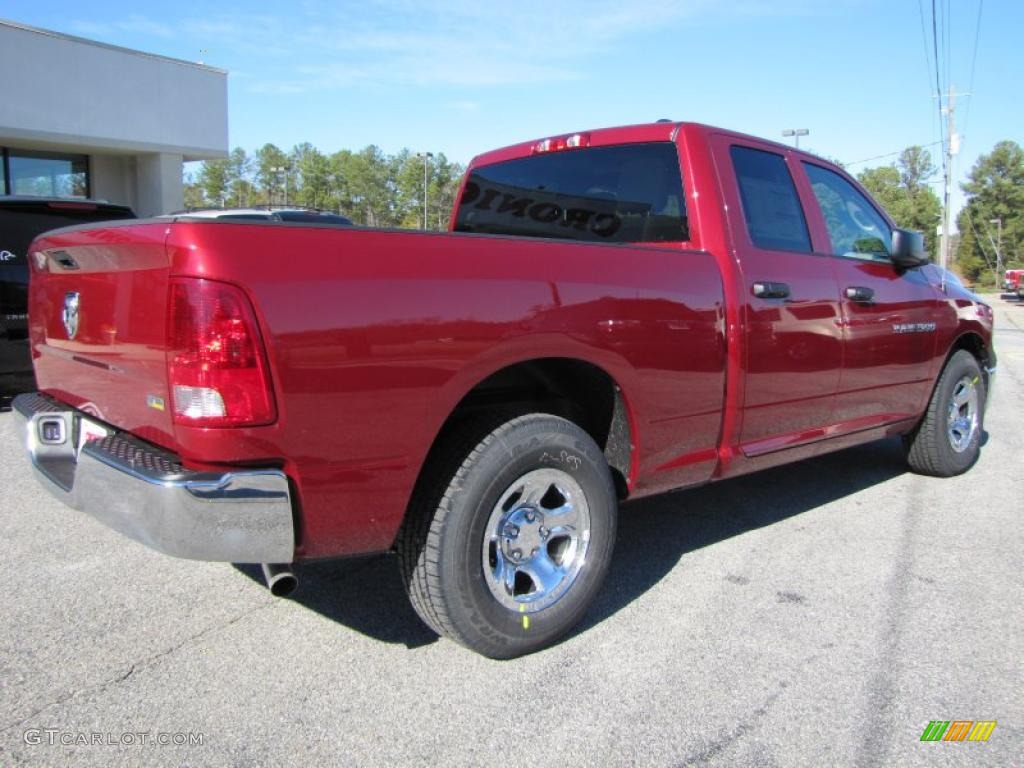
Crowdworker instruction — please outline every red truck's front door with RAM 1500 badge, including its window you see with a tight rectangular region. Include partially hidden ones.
[802,160,939,431]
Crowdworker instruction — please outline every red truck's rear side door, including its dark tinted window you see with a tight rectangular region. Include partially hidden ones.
[712,134,842,457]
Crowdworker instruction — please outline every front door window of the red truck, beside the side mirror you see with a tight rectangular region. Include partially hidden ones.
[804,163,892,260]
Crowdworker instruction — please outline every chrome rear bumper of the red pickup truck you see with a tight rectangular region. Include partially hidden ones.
[12,393,295,563]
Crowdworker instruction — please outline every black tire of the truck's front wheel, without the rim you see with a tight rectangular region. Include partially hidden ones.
[904,349,987,477]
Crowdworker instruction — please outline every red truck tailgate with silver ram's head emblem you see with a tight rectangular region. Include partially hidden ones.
[29,222,173,445]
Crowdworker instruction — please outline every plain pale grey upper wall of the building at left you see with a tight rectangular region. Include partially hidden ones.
[0,19,228,160]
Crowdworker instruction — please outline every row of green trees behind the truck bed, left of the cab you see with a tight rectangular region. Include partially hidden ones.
[185,142,465,229]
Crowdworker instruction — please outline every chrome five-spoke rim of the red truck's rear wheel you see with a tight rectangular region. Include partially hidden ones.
[483,469,590,613]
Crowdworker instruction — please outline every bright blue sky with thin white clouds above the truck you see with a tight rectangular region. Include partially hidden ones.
[2,0,1024,214]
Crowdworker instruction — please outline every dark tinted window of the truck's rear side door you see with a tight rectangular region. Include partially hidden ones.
[730,146,811,253]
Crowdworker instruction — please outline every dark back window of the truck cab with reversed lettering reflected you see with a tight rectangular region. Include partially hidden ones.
[456,141,689,243]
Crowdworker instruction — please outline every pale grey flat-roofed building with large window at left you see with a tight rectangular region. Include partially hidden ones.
[0,19,227,216]
